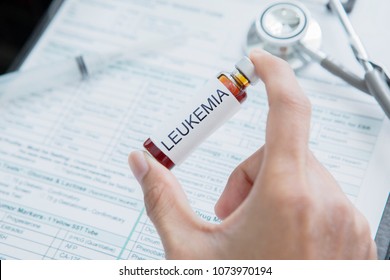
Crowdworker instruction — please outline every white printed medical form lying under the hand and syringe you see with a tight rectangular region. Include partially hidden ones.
[0,0,390,259]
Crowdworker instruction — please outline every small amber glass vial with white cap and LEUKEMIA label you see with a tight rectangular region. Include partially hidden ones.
[144,57,259,169]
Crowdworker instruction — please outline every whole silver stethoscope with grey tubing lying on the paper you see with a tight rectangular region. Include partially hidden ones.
[245,0,390,119]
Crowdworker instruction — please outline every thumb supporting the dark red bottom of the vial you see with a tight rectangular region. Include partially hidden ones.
[129,151,203,251]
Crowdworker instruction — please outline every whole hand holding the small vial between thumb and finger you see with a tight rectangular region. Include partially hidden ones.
[129,51,376,259]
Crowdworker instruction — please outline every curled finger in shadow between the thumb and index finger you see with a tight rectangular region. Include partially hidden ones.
[214,148,264,219]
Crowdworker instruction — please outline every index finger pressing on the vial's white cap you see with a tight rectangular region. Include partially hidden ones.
[250,50,311,157]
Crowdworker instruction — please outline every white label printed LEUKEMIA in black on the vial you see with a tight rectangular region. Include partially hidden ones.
[150,79,240,165]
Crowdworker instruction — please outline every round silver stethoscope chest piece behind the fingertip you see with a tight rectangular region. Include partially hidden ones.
[245,1,322,70]
